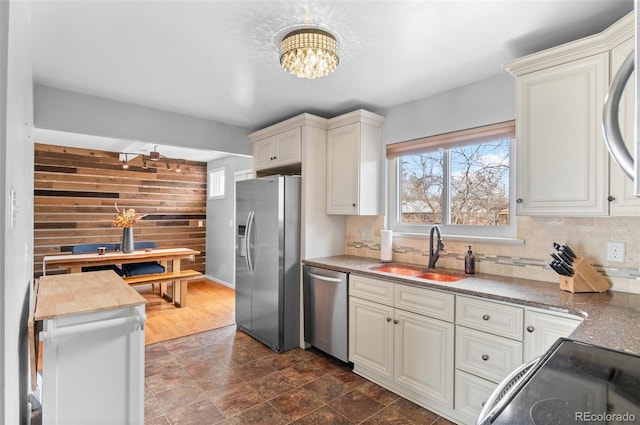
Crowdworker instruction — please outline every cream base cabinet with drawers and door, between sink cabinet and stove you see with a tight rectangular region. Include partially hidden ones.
[455,295,581,424]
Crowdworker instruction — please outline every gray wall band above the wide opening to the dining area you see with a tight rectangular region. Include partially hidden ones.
[34,84,251,155]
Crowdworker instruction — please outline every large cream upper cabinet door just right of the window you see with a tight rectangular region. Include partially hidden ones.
[516,52,609,216]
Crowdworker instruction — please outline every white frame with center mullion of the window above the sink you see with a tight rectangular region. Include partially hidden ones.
[387,121,517,240]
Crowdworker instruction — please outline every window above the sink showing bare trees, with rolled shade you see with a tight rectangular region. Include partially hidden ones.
[387,121,516,238]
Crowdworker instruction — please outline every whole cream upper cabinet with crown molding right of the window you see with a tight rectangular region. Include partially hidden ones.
[504,14,640,216]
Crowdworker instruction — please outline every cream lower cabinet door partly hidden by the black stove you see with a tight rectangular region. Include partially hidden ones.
[524,310,582,362]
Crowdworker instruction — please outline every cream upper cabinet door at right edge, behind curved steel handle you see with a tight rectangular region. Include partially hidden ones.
[609,38,640,216]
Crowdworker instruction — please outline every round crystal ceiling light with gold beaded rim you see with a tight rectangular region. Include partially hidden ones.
[280,28,340,80]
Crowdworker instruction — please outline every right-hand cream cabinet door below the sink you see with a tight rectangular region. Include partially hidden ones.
[394,310,454,408]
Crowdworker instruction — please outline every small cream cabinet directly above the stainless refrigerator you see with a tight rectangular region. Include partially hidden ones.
[253,127,302,171]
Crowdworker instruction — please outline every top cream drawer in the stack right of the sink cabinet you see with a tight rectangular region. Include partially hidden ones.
[456,296,524,341]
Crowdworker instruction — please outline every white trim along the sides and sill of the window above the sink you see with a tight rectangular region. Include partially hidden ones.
[387,138,524,240]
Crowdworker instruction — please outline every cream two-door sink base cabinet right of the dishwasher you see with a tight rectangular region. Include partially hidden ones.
[349,274,454,410]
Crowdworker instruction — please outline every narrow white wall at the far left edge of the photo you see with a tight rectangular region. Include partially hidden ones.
[0,1,33,424]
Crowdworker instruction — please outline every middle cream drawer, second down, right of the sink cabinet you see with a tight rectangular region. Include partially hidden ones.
[456,326,522,383]
